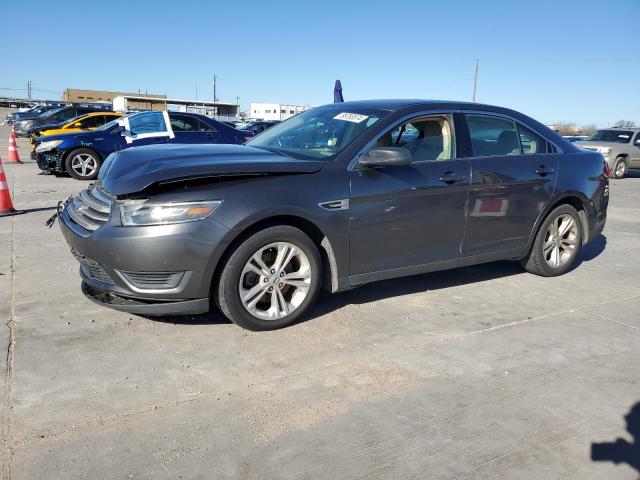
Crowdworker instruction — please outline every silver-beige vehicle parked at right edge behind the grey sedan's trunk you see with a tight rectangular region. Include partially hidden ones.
[576,127,640,178]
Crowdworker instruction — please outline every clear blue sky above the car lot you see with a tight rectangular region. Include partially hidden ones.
[0,0,640,126]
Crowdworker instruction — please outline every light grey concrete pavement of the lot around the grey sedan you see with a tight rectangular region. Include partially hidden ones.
[0,117,640,480]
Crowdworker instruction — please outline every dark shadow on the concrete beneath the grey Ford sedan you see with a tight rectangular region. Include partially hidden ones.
[150,235,607,325]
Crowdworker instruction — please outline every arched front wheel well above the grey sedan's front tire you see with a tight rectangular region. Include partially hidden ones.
[211,215,338,291]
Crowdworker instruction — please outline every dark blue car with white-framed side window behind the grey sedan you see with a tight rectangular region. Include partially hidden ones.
[34,112,254,180]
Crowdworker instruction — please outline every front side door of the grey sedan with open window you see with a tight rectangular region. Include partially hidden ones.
[349,114,469,278]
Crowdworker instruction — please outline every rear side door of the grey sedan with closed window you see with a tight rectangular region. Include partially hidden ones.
[462,114,558,258]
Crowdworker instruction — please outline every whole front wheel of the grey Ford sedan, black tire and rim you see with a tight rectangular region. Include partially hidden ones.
[218,225,322,331]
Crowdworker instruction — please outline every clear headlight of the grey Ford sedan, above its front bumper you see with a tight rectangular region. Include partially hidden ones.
[120,200,222,226]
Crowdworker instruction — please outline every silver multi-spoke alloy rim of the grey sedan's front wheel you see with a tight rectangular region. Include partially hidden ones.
[238,242,312,320]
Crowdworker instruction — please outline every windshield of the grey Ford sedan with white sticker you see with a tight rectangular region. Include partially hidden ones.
[245,105,387,160]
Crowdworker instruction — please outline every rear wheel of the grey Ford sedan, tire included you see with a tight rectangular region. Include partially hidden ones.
[521,205,582,277]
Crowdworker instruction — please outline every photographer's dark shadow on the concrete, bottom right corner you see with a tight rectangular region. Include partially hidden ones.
[591,402,640,473]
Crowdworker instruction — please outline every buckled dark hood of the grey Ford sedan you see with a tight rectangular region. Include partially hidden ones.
[99,144,326,196]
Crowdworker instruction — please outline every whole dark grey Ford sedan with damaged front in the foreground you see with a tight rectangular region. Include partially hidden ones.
[59,100,609,330]
